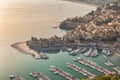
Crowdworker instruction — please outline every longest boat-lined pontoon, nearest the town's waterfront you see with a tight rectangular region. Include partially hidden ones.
[73,57,115,75]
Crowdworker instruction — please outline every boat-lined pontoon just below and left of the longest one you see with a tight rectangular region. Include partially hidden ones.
[66,63,96,79]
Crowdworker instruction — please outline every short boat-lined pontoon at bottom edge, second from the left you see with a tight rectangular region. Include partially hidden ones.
[30,72,51,80]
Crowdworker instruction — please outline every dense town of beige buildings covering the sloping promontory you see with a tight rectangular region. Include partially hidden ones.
[23,2,120,55]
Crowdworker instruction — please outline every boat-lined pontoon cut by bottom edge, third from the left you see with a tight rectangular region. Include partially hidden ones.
[49,66,79,80]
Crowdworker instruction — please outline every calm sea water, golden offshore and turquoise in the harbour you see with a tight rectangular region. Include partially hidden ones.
[0,0,120,80]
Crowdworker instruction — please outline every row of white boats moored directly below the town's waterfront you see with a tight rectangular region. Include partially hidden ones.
[68,47,114,58]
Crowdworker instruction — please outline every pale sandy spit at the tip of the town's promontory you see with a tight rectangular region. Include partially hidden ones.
[11,42,41,59]
